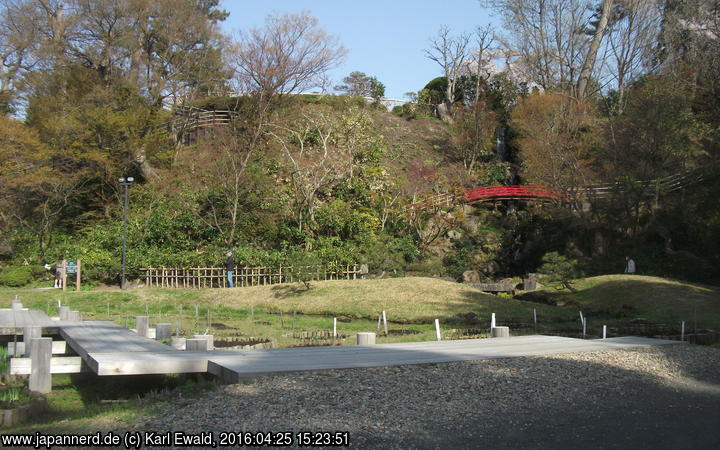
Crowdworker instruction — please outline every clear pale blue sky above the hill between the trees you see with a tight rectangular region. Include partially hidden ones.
[222,0,496,99]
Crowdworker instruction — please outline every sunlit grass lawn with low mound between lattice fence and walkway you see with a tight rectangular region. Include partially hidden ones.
[0,277,574,345]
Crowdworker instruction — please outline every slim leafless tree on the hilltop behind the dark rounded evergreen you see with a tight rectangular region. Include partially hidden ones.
[425,26,470,117]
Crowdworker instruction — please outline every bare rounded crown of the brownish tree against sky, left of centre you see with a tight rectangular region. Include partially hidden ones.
[231,11,347,96]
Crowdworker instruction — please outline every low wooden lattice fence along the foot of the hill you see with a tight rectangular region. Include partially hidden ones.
[140,264,360,289]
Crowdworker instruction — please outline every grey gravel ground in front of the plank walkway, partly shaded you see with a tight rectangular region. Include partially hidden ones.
[136,345,720,449]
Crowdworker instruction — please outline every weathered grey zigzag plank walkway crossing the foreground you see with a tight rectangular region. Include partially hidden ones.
[0,310,678,382]
